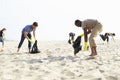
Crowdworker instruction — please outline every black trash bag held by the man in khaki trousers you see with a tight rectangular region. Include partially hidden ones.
[73,36,82,55]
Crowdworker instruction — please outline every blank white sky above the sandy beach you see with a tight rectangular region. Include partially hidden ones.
[0,0,120,41]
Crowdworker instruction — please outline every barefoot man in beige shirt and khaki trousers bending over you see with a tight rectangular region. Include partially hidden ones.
[75,19,102,56]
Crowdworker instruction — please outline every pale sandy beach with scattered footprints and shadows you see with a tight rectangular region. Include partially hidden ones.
[0,40,120,80]
